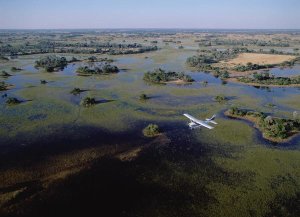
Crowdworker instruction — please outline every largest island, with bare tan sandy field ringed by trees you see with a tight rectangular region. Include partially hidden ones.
[186,48,300,86]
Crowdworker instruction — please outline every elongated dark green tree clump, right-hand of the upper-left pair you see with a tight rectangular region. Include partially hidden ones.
[76,64,119,74]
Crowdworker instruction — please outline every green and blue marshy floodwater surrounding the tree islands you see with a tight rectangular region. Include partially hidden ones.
[0,53,300,216]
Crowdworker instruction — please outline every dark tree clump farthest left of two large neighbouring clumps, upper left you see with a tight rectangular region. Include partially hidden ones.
[35,55,68,72]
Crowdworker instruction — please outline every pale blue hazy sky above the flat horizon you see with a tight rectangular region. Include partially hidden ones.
[0,0,300,29]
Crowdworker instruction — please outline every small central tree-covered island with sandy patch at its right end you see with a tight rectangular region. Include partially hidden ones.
[143,68,194,84]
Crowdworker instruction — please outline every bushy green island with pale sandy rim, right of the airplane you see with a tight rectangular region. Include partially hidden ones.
[224,107,300,143]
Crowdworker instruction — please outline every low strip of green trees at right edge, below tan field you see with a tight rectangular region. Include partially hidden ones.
[238,72,300,85]
